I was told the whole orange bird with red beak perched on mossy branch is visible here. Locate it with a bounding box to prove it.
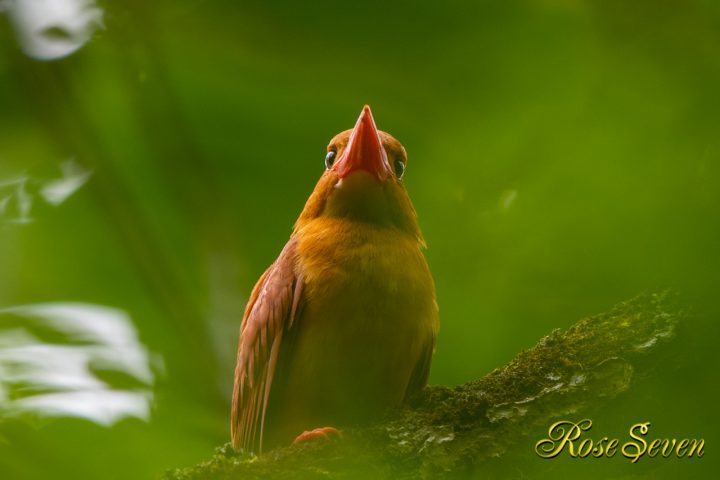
[231,105,438,452]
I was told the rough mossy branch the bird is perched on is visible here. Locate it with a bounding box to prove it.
[164,292,684,480]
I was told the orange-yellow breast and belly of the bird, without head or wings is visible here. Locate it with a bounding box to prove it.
[268,217,438,448]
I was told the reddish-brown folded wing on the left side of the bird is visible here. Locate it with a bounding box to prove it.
[230,238,302,451]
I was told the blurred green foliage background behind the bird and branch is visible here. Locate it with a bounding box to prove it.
[0,0,720,479]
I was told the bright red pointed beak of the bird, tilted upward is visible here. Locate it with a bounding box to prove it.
[333,105,391,183]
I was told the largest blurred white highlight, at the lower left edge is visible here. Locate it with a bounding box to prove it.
[0,303,155,426]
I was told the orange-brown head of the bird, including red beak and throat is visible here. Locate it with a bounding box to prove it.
[295,105,423,243]
